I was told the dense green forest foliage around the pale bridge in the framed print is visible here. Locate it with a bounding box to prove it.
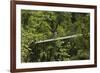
[21,10,90,62]
